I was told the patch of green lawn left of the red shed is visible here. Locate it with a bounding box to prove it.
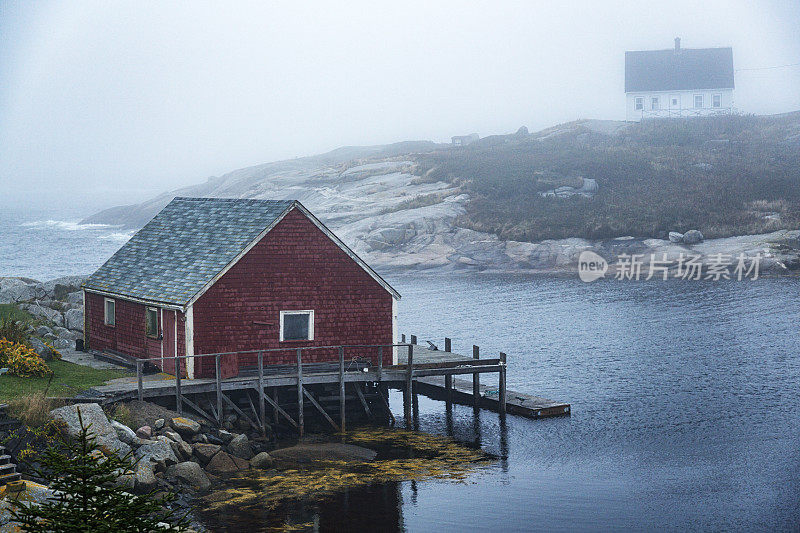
[0,361,130,401]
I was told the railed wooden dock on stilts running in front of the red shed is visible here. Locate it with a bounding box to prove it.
[94,335,570,435]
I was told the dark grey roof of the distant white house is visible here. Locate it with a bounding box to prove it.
[625,48,734,93]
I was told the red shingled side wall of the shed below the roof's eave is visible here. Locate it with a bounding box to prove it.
[85,292,186,372]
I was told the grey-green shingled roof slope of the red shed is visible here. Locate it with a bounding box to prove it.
[84,198,294,306]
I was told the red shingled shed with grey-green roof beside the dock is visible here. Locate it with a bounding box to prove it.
[83,198,400,378]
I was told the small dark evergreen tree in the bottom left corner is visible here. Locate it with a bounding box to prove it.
[11,410,188,533]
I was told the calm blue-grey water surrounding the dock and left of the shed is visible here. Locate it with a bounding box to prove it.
[0,210,800,532]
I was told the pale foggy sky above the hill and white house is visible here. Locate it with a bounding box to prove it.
[0,0,800,210]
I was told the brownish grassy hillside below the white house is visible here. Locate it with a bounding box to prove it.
[416,113,800,241]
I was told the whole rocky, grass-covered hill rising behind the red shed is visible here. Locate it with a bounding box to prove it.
[84,112,800,271]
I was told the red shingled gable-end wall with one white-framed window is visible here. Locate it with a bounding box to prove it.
[194,209,393,377]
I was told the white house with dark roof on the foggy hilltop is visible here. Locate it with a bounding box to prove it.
[625,38,734,121]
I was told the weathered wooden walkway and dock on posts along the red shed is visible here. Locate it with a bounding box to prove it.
[87,336,570,435]
